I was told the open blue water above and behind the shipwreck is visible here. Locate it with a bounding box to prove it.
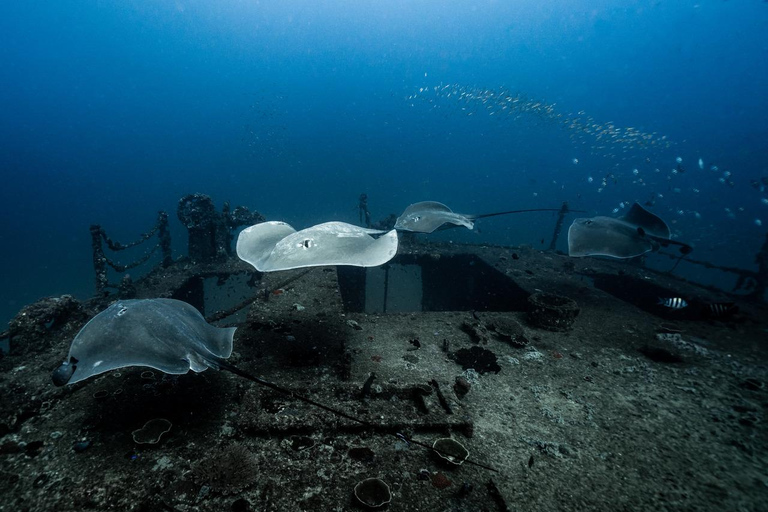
[0,0,768,321]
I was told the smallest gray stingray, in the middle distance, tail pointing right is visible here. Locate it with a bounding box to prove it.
[395,201,573,233]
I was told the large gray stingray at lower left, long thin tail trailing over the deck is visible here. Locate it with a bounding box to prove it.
[52,299,496,471]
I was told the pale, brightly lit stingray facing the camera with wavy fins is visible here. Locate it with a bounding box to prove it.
[237,221,397,272]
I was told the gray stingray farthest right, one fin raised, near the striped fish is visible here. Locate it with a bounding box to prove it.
[568,203,693,258]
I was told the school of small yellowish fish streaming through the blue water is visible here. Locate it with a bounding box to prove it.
[406,84,768,234]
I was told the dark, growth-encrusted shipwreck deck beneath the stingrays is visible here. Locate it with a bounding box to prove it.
[0,244,768,512]
